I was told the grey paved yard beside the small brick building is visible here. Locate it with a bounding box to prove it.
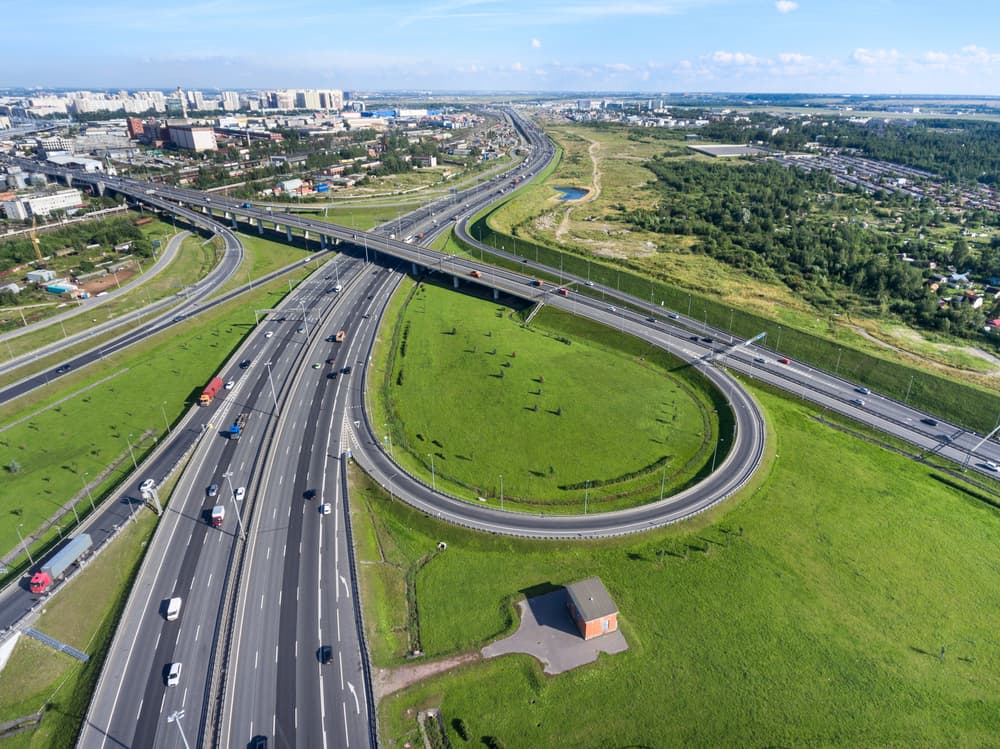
[483,588,628,674]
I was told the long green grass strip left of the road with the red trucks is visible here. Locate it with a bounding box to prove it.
[0,262,308,572]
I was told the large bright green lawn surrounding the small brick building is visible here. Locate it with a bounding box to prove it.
[364,392,1000,749]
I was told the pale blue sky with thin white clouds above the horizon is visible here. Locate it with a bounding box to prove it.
[7,0,1000,95]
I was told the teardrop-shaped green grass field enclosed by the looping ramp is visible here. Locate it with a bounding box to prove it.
[371,283,718,512]
